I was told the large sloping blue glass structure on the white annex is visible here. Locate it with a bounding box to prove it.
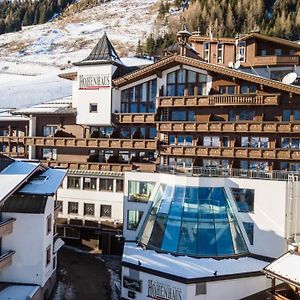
[138,184,248,257]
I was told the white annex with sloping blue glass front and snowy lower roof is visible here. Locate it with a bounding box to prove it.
[122,169,300,300]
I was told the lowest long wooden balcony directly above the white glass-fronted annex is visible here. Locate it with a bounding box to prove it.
[160,145,300,160]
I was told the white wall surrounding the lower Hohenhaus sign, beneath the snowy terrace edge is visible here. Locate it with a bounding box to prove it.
[122,266,271,300]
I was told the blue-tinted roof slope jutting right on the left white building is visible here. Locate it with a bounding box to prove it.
[19,169,67,195]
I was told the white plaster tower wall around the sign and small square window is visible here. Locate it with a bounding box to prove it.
[73,64,115,126]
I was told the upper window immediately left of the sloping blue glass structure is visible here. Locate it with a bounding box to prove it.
[128,181,155,202]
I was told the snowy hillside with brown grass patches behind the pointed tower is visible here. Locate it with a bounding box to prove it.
[0,0,159,107]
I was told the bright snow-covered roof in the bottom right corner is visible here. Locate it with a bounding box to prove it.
[264,251,300,288]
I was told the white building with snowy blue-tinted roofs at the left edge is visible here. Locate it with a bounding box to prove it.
[0,156,66,299]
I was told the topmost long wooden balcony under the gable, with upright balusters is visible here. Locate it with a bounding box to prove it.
[157,94,280,107]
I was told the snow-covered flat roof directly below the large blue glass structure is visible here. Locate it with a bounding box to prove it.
[122,243,268,279]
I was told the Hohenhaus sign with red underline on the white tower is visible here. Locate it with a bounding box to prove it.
[79,74,111,90]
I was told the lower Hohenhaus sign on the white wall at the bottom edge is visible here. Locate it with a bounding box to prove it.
[148,280,182,300]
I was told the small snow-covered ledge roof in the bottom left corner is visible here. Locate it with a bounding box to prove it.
[0,285,40,300]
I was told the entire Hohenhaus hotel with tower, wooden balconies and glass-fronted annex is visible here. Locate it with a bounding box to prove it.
[0,30,300,300]
